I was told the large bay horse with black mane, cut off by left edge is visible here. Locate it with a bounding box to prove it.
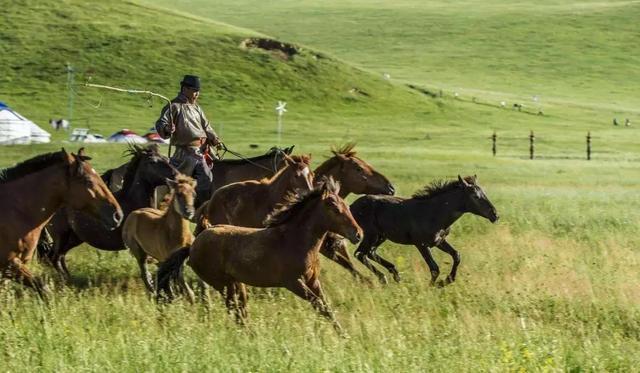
[0,149,123,296]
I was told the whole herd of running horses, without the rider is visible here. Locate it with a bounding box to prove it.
[0,144,498,328]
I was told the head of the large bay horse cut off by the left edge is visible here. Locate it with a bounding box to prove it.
[62,148,124,229]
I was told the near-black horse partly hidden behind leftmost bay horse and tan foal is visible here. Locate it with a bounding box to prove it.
[40,144,178,278]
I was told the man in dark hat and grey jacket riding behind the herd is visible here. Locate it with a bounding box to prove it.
[155,75,222,206]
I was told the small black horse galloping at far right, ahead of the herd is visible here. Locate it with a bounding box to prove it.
[351,176,498,285]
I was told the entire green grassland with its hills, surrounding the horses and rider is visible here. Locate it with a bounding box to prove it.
[0,0,640,372]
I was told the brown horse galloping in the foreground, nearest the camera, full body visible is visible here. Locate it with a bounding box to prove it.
[158,180,362,329]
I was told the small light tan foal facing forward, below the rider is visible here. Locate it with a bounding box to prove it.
[122,175,196,292]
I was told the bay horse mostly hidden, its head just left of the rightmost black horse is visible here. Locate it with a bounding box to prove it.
[314,143,395,281]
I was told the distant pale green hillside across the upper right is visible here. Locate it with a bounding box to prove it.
[154,0,640,109]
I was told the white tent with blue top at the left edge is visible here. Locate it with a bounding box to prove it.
[0,102,51,145]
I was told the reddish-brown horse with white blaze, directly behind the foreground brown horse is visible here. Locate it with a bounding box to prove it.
[195,155,313,231]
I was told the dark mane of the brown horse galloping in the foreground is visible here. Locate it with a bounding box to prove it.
[263,178,340,228]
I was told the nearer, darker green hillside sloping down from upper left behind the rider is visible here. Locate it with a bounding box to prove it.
[0,0,435,141]
